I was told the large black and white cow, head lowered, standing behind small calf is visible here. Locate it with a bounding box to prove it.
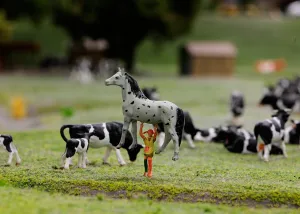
[60,122,144,166]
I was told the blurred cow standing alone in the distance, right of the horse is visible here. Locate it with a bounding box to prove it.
[230,91,245,125]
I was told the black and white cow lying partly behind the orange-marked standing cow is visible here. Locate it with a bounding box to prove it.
[219,126,282,154]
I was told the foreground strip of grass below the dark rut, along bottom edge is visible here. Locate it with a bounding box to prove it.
[0,187,298,214]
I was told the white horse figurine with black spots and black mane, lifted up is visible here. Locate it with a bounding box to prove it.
[105,68,184,161]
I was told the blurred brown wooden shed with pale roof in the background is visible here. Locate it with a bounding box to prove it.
[181,41,237,77]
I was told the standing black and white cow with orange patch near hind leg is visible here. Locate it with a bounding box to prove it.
[254,109,290,161]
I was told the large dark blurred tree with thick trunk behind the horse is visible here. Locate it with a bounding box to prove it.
[0,0,202,71]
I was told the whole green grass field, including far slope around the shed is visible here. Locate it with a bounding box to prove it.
[0,15,300,213]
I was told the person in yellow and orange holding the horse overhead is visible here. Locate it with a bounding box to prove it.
[140,123,157,178]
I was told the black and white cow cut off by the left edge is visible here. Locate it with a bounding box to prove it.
[0,134,21,166]
